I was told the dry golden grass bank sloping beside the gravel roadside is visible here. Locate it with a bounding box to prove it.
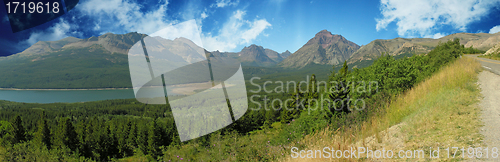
[283,57,481,161]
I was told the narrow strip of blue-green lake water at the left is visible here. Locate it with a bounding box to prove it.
[0,89,135,103]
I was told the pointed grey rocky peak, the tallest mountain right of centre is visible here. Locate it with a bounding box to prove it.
[279,30,360,68]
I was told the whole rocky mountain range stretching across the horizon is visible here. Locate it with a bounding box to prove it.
[0,30,500,88]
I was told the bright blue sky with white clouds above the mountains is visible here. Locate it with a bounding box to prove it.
[0,0,500,56]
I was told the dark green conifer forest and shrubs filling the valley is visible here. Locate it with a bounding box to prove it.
[0,39,484,161]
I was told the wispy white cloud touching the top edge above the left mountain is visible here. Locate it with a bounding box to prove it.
[78,0,170,34]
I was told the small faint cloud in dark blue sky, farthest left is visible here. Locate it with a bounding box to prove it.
[19,19,80,47]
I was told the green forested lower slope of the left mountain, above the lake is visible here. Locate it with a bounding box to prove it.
[0,45,132,89]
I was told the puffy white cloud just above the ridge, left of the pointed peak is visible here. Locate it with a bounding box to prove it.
[201,10,271,51]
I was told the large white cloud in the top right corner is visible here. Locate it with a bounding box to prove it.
[376,0,499,37]
